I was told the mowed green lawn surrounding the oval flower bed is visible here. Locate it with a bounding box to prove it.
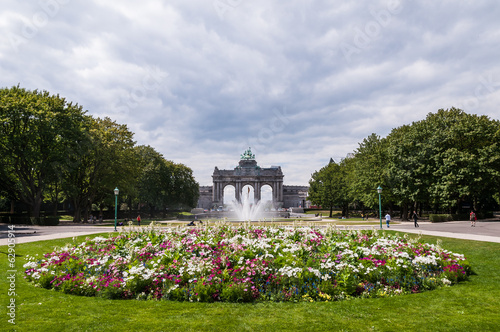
[0,234,500,331]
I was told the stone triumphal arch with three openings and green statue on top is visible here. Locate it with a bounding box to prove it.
[212,148,283,207]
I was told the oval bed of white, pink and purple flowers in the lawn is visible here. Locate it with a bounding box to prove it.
[24,225,471,302]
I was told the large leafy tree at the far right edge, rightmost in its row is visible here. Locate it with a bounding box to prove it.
[424,108,499,212]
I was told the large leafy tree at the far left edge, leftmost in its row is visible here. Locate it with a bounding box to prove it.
[0,86,85,217]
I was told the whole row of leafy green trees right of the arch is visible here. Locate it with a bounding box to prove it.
[310,108,500,218]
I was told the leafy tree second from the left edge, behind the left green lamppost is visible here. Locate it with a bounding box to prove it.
[63,118,138,222]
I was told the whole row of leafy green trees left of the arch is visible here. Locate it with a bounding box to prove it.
[0,86,198,221]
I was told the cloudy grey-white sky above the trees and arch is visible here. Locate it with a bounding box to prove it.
[0,0,500,185]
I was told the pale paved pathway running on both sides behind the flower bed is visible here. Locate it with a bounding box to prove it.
[0,220,500,245]
